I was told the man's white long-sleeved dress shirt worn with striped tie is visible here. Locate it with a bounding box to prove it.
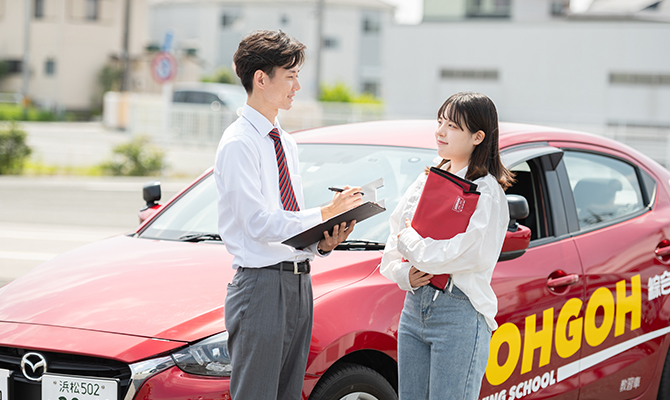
[214,104,321,269]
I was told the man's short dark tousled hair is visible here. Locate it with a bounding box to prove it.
[233,31,305,93]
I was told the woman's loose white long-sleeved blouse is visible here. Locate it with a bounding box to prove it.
[381,167,509,331]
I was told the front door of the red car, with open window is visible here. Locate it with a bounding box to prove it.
[479,143,583,400]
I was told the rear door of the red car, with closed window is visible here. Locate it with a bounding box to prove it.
[563,144,670,400]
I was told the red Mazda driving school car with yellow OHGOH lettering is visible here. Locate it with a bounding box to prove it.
[0,121,670,400]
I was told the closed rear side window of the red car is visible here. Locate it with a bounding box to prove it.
[563,151,645,229]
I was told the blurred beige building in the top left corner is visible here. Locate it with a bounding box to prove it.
[0,0,147,110]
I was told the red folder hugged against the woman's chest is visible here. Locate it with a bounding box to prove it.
[412,167,480,291]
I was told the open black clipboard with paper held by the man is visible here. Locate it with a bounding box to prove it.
[282,178,386,249]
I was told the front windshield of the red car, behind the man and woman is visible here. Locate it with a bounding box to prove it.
[140,144,437,243]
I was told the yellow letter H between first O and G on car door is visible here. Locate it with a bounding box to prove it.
[521,308,554,374]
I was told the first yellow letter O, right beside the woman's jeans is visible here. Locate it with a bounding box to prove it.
[486,322,521,386]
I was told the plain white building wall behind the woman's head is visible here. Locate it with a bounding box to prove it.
[383,20,670,125]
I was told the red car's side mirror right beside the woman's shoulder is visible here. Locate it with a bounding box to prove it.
[498,194,530,261]
